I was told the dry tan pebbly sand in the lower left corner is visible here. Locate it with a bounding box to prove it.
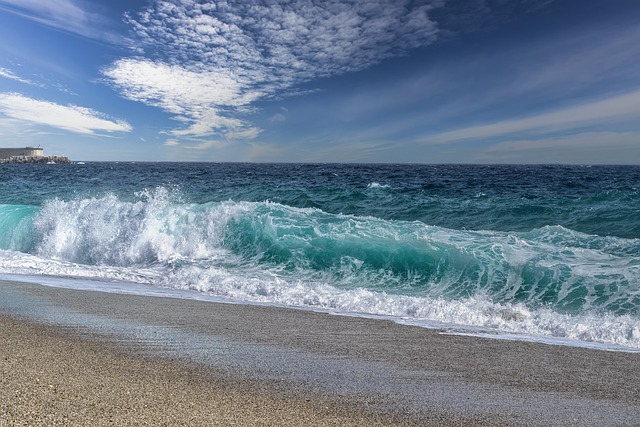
[0,316,418,427]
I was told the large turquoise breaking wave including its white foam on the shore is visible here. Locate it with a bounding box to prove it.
[0,188,640,348]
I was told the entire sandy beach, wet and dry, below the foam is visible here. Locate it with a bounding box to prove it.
[0,281,640,427]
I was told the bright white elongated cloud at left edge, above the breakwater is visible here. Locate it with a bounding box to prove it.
[0,93,132,135]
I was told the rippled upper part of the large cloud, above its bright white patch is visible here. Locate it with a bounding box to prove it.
[130,0,439,85]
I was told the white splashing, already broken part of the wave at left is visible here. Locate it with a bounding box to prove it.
[34,188,241,266]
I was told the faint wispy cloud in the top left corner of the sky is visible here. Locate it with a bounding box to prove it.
[0,0,125,44]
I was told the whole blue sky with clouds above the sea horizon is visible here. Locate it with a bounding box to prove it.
[0,0,640,164]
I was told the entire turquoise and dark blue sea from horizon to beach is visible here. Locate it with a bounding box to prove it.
[0,162,640,351]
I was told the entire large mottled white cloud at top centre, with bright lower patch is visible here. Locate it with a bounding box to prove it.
[103,0,442,143]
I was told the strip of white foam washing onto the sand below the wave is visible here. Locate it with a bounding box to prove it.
[0,251,640,351]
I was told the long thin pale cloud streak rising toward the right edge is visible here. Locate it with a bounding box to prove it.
[423,91,640,144]
